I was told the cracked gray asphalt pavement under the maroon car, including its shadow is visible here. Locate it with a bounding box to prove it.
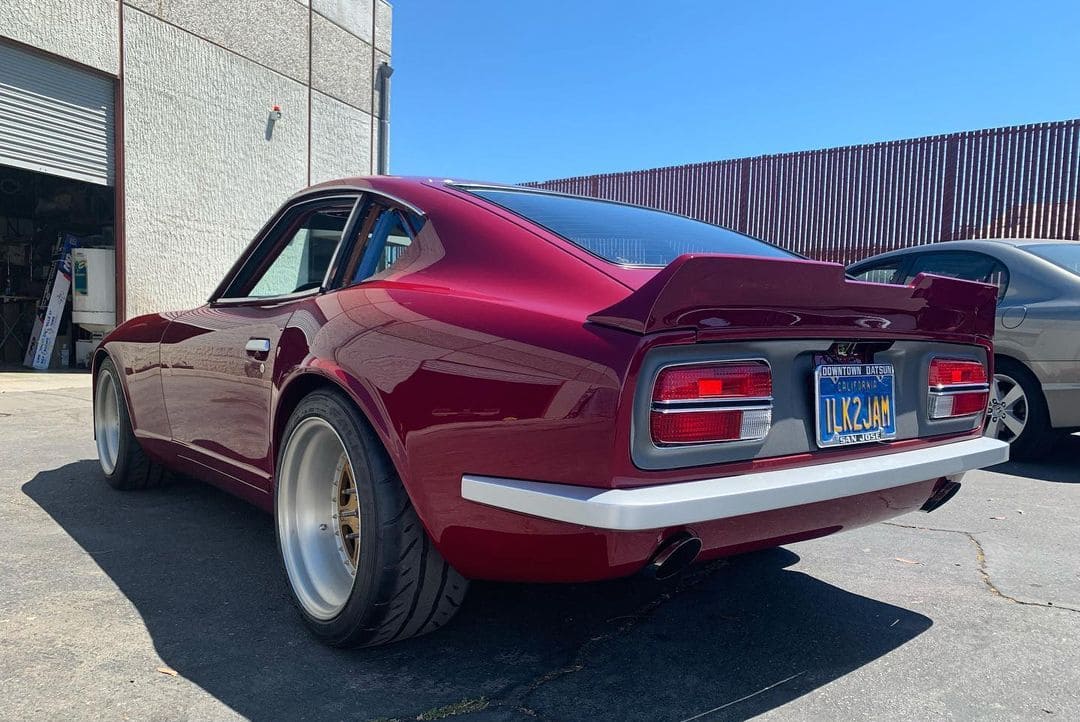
[0,373,1080,722]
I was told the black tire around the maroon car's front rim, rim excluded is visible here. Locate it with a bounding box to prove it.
[94,358,164,491]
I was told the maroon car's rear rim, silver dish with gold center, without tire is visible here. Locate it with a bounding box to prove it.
[278,417,361,619]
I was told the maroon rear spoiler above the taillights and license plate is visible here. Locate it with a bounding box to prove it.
[589,255,997,340]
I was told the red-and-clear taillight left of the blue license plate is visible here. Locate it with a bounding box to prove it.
[649,360,772,446]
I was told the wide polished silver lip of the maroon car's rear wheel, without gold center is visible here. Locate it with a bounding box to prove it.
[274,416,363,622]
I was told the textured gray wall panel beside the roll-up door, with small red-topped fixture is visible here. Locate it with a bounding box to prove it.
[124,8,308,317]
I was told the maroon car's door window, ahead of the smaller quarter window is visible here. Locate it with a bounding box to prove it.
[225,199,355,299]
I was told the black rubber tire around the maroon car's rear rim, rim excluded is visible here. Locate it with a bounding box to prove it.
[274,390,469,646]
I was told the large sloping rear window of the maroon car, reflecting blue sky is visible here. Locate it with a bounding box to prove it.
[465,188,799,265]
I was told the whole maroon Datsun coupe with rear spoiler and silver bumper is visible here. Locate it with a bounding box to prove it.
[93,177,1008,645]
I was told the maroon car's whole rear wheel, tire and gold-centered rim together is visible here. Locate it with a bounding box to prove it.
[274,391,469,646]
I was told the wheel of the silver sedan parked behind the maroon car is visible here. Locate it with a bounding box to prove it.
[986,359,1054,459]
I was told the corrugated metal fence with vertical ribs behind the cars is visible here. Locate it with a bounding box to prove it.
[524,119,1080,263]
